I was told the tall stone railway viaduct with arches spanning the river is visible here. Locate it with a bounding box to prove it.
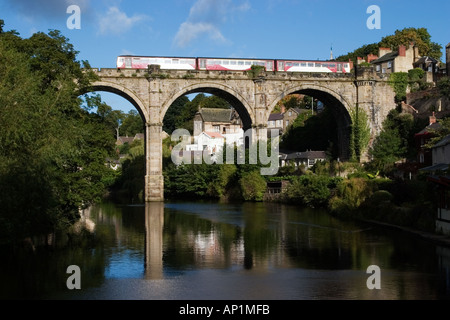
[91,66,396,202]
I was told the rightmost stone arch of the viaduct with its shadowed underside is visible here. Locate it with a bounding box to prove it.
[266,84,354,160]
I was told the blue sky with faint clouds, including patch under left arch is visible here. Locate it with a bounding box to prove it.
[0,0,450,112]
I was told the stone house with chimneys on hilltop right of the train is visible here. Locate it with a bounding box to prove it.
[371,44,420,74]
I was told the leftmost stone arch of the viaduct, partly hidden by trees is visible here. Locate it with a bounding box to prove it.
[86,81,149,123]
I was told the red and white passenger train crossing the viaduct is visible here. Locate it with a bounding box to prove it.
[117,56,352,73]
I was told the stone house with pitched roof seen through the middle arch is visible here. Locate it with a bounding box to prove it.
[194,108,242,137]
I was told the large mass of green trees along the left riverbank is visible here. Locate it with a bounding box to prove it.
[0,23,115,241]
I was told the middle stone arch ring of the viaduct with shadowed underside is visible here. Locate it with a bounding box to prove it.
[161,82,255,130]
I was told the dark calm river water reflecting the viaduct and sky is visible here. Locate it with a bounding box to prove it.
[0,202,450,300]
